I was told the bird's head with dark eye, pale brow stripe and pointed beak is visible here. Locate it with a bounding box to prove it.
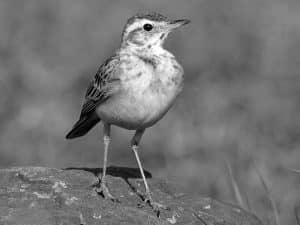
[122,13,190,49]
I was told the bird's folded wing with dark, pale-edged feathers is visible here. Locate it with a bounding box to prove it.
[80,56,120,118]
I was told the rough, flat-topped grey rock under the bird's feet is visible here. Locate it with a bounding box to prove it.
[0,167,262,225]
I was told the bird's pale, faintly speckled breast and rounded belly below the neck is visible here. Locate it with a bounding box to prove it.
[98,53,183,129]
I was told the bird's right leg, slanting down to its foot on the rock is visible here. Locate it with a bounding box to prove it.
[131,129,167,213]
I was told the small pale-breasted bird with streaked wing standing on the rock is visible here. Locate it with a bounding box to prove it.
[66,12,190,210]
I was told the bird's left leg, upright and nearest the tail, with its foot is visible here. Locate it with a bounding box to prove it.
[96,123,117,201]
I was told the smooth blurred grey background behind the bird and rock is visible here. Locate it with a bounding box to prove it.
[0,0,300,224]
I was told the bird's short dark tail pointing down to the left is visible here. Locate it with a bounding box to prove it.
[66,113,100,139]
